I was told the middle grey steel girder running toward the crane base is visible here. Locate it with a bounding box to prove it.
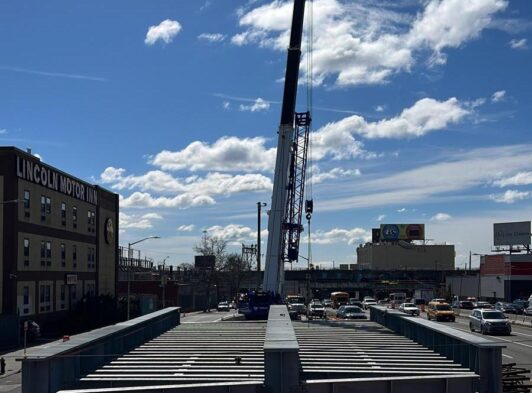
[264,305,300,393]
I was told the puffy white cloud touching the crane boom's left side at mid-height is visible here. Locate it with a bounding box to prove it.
[152,137,276,172]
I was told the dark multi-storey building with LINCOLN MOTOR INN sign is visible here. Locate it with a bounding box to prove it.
[0,147,118,322]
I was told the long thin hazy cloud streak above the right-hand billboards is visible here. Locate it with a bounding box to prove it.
[320,145,532,211]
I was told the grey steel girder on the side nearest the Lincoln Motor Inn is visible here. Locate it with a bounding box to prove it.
[18,307,180,393]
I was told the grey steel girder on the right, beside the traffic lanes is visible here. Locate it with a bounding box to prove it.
[370,306,506,393]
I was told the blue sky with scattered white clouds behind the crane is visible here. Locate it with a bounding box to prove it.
[0,0,532,266]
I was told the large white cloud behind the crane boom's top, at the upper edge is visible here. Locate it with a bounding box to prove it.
[231,0,508,86]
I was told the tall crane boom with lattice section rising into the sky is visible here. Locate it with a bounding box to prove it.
[262,0,310,294]
